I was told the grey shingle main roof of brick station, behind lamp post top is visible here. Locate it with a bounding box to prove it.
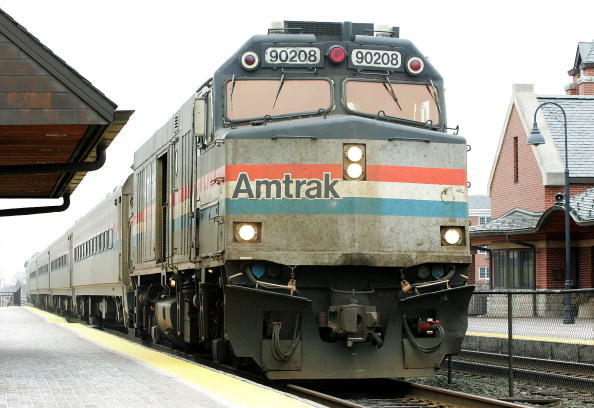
[537,96,594,177]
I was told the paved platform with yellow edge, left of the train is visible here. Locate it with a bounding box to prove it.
[0,306,319,408]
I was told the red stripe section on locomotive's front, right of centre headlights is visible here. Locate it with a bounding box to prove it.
[367,165,466,186]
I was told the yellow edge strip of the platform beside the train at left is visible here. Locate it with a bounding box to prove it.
[24,306,312,408]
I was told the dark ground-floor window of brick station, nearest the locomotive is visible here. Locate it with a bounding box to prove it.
[493,248,535,289]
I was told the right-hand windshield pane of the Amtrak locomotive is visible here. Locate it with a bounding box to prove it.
[344,80,439,125]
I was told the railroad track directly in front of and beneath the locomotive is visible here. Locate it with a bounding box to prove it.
[286,379,527,408]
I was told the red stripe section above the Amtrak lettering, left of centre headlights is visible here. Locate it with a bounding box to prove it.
[225,164,342,181]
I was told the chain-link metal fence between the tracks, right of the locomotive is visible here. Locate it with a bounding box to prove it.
[444,289,594,397]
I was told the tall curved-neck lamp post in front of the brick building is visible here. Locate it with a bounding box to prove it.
[527,102,575,324]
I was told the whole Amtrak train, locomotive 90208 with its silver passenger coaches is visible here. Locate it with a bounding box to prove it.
[27,21,474,380]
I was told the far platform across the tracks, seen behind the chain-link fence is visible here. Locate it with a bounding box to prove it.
[462,316,594,364]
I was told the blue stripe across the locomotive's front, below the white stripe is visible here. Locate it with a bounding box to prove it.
[226,197,468,218]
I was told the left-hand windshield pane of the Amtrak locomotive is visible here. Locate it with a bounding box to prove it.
[227,76,332,120]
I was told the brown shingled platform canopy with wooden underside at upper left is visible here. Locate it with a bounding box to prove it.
[0,10,132,198]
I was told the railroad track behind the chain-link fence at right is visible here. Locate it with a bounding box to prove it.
[452,350,594,392]
